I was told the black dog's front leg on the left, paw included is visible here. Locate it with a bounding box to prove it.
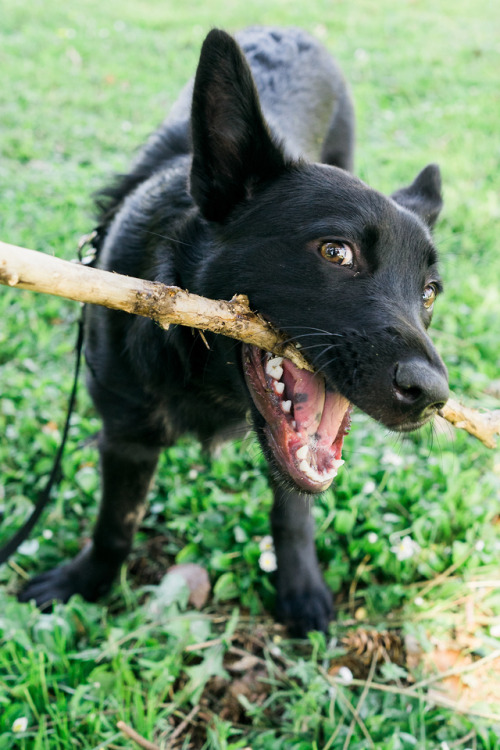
[19,434,159,607]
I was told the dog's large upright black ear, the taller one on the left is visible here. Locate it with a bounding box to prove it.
[190,29,286,221]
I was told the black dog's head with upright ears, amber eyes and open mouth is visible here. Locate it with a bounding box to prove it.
[190,31,448,493]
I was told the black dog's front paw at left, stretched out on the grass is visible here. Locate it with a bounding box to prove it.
[18,547,117,610]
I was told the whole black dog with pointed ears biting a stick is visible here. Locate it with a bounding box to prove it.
[21,29,448,634]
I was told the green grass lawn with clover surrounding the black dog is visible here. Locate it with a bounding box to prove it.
[0,0,500,750]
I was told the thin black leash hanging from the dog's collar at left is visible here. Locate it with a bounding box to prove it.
[0,230,98,565]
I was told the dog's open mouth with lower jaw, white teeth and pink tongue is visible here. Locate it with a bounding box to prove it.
[243,344,352,493]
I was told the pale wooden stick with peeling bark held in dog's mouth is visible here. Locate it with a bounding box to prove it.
[0,241,500,448]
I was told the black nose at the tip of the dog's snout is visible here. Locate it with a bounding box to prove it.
[394,358,449,411]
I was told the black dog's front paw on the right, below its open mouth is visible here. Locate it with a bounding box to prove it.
[276,581,333,638]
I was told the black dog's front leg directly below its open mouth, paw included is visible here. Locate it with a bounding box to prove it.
[271,486,333,637]
